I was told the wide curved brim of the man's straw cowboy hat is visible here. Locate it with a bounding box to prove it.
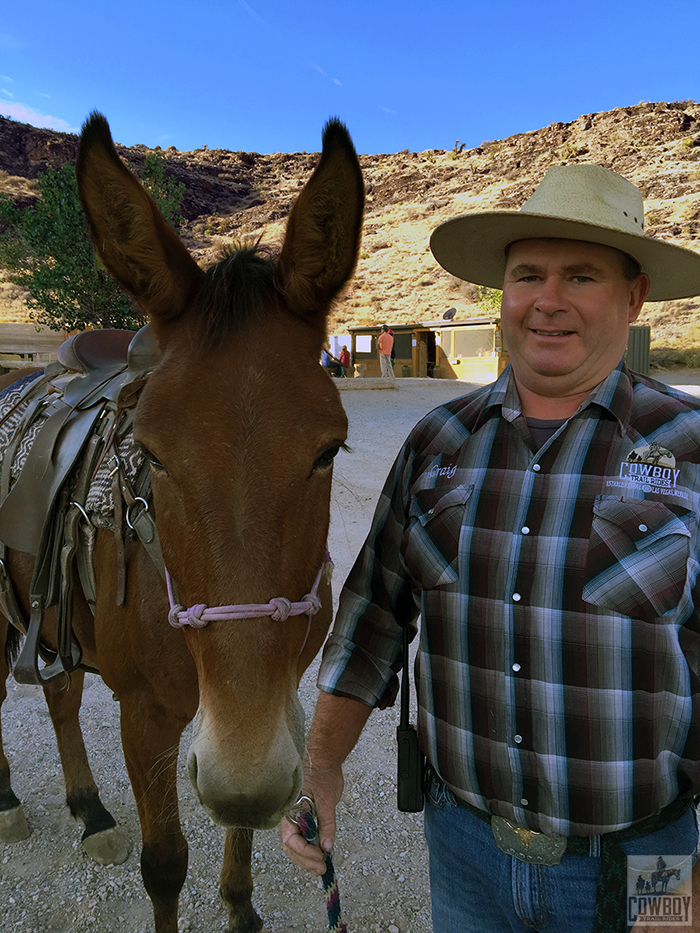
[430,211,700,301]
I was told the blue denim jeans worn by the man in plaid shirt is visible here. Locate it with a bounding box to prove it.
[425,785,698,933]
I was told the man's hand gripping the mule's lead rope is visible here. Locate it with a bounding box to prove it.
[280,761,343,877]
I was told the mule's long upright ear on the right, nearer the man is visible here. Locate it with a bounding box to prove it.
[277,120,365,325]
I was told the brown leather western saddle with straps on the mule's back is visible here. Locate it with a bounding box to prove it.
[0,325,164,684]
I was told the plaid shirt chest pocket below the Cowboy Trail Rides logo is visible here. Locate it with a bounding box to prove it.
[583,496,696,621]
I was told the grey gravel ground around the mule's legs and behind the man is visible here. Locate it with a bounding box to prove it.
[0,379,476,933]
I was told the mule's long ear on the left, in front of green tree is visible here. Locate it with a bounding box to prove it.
[76,112,203,330]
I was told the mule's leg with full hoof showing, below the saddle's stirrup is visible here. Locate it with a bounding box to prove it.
[44,671,130,865]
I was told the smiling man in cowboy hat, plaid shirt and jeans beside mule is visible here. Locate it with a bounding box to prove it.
[282,165,700,933]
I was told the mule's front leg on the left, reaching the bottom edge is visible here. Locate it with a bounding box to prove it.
[121,692,187,933]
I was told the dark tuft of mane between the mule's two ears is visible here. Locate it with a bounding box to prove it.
[196,243,277,352]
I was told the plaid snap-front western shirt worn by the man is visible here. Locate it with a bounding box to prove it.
[319,364,700,836]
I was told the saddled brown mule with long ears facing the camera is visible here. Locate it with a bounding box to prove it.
[0,114,364,933]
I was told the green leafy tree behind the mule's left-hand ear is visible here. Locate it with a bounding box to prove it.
[0,153,184,330]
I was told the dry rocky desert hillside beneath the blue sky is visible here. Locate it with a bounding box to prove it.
[0,101,700,348]
